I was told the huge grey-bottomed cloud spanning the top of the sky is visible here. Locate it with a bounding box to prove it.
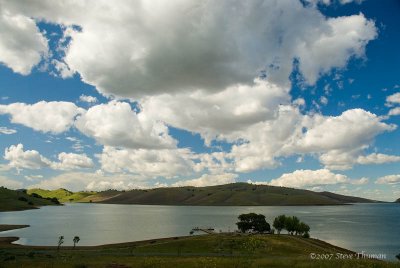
[2,0,377,98]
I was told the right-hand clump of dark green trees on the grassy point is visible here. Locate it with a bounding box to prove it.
[272,215,310,237]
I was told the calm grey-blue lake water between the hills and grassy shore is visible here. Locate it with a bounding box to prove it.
[0,204,400,259]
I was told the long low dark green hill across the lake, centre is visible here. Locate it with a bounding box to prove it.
[93,183,376,206]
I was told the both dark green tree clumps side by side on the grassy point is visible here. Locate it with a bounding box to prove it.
[236,213,310,237]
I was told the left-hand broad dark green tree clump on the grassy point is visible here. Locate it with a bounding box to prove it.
[236,213,271,233]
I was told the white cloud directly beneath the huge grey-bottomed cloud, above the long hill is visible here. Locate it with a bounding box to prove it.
[141,79,290,144]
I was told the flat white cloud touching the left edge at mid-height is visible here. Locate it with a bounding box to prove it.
[0,101,84,134]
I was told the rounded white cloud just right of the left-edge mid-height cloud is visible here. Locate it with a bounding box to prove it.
[75,101,176,149]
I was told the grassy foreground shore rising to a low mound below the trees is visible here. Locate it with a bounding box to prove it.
[0,234,399,268]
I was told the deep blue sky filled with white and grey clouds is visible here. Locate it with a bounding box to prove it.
[0,0,400,201]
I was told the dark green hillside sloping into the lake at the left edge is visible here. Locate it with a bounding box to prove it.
[0,187,58,211]
